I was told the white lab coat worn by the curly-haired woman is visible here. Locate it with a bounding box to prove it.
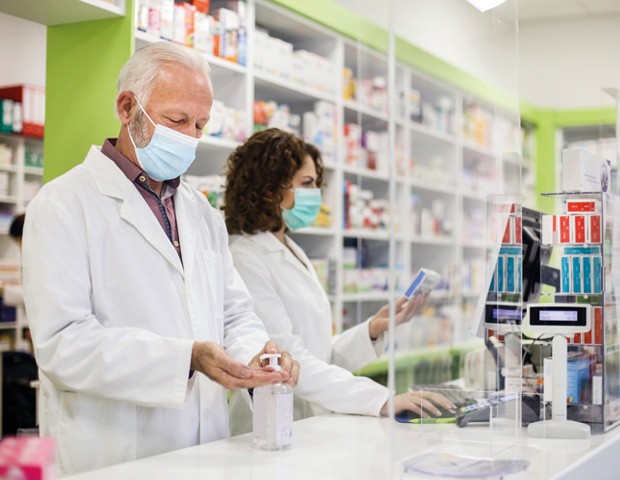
[230,232,388,434]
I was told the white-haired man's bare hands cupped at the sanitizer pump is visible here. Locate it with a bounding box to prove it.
[190,341,299,390]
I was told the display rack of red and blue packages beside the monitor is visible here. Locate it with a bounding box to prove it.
[541,192,620,431]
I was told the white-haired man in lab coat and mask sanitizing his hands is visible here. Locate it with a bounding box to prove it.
[23,42,299,473]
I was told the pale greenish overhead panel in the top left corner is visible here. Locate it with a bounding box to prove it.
[0,0,125,25]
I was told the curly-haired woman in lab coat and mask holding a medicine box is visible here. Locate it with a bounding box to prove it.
[224,128,454,433]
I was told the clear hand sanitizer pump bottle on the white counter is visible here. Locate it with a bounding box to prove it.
[252,353,293,450]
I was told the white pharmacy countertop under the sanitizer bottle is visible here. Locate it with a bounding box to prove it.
[65,414,620,480]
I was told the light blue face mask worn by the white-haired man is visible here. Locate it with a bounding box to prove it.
[128,98,199,182]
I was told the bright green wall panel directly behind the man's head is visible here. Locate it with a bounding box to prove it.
[43,0,134,181]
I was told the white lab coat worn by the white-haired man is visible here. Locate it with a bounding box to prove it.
[23,147,267,473]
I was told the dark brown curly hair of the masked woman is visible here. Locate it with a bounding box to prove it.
[223,128,323,234]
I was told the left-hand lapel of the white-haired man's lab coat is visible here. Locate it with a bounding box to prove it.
[84,147,183,275]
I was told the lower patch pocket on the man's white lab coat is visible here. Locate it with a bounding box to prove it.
[57,391,137,473]
